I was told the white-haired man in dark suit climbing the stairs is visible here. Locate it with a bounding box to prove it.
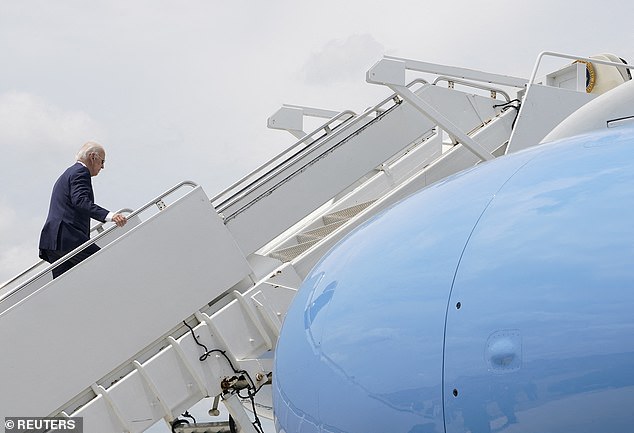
[39,141,127,278]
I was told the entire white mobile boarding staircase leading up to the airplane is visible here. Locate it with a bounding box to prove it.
[0,51,628,433]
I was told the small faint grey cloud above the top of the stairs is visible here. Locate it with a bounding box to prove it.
[302,34,385,85]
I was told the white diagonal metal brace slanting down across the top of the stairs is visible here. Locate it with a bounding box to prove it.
[366,58,494,161]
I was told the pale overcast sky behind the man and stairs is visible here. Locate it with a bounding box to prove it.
[0,0,634,426]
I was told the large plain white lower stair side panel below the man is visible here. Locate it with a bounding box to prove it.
[0,187,249,418]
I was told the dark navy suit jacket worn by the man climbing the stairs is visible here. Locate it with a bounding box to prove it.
[39,162,108,259]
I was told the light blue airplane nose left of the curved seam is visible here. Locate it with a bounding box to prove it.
[274,148,532,433]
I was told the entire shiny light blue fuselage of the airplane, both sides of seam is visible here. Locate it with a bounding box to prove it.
[273,128,634,433]
